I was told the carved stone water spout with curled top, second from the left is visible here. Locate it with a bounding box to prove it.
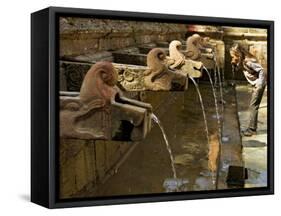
[143,48,186,91]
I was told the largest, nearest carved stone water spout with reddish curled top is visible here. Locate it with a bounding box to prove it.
[60,62,152,141]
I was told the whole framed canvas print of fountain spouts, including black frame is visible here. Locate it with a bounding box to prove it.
[31,7,274,208]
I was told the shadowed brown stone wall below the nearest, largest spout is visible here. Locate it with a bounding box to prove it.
[60,139,133,199]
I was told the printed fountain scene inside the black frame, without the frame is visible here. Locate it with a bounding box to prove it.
[57,17,268,199]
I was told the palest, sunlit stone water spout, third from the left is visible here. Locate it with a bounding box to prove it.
[165,40,203,78]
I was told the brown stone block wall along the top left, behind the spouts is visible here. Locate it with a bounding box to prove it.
[60,17,186,57]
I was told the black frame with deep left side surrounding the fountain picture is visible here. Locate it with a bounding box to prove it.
[31,7,274,208]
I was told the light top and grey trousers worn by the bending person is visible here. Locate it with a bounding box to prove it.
[243,58,266,131]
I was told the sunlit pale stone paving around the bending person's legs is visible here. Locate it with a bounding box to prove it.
[236,84,267,188]
